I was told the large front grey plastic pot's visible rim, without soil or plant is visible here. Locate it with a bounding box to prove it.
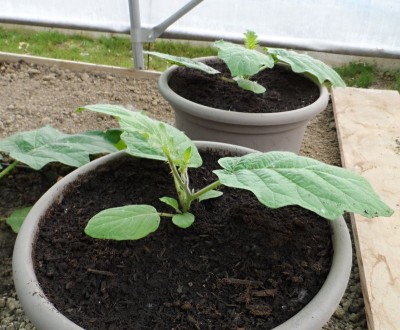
[13,142,352,330]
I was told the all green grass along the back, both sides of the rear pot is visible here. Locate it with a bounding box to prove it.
[0,27,400,91]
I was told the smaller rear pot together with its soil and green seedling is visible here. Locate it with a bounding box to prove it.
[147,31,345,153]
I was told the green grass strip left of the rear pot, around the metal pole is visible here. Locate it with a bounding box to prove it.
[0,27,216,70]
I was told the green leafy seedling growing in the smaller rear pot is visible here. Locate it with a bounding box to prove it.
[145,31,345,94]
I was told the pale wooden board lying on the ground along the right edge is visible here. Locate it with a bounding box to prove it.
[332,88,400,330]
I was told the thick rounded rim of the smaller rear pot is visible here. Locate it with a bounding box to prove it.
[158,56,329,126]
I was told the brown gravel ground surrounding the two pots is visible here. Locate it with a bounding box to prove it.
[0,60,367,330]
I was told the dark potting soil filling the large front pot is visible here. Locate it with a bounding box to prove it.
[34,153,332,330]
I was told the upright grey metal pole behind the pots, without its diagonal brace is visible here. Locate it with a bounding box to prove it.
[128,0,144,70]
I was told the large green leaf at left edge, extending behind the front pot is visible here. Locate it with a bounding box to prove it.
[0,126,117,170]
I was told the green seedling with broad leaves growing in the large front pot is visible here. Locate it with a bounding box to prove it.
[78,105,393,240]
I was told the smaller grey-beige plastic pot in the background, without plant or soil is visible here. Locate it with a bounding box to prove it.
[158,57,329,153]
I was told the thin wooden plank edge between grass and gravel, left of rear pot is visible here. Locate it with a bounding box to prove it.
[0,52,160,80]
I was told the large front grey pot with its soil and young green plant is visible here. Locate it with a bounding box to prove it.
[13,105,392,330]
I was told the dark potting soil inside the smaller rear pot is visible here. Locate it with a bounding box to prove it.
[169,61,319,113]
